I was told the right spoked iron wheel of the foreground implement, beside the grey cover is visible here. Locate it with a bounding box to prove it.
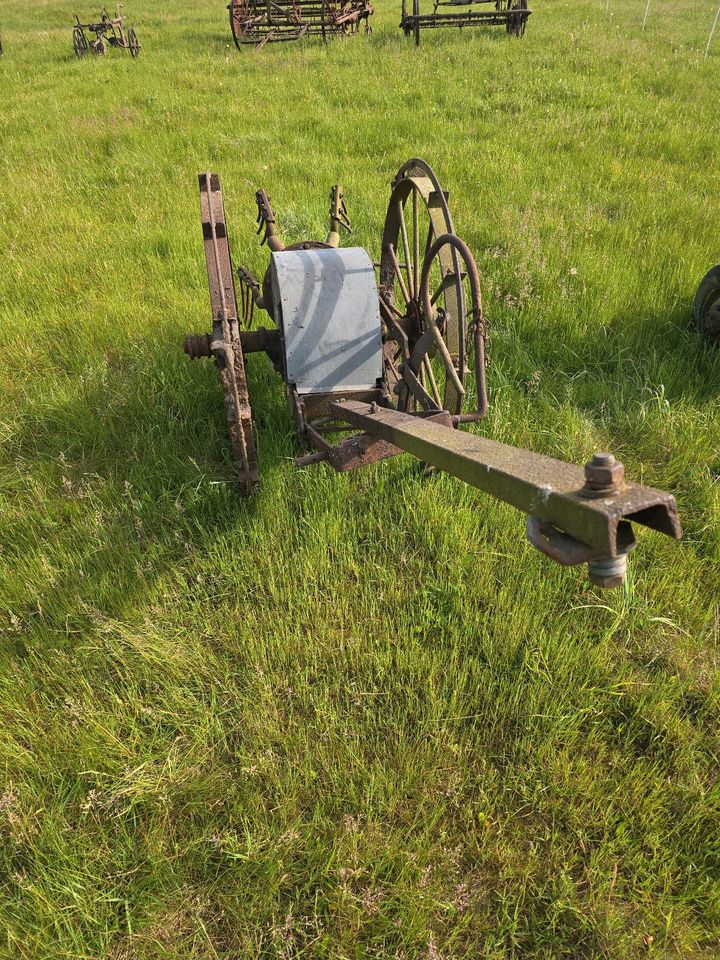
[379,159,487,419]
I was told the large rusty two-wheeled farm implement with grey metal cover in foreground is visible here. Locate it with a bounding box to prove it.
[185,160,680,587]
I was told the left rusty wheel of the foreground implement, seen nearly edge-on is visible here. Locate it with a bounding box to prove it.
[185,173,260,494]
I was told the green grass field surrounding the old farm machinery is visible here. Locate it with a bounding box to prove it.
[0,0,720,960]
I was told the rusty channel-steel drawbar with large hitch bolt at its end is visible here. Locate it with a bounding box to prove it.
[332,401,682,586]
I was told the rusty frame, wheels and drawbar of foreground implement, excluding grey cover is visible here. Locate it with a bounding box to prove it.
[185,160,681,587]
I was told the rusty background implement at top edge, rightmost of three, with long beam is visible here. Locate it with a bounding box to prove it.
[400,0,532,45]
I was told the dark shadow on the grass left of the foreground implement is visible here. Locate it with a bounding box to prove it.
[5,338,297,655]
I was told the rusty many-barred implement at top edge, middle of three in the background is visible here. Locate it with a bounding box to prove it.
[228,0,374,50]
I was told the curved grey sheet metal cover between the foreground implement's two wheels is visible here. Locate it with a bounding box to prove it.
[272,247,382,394]
